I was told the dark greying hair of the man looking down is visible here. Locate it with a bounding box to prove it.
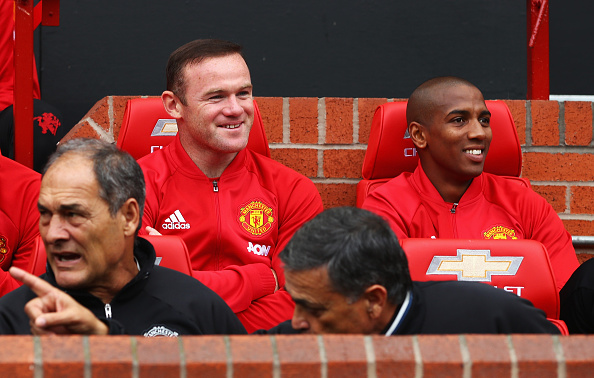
[280,207,412,305]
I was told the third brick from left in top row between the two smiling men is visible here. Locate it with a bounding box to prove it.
[325,97,353,144]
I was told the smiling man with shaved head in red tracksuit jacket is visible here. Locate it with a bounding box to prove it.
[363,77,579,290]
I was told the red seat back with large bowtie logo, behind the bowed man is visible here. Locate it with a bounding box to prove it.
[401,238,559,319]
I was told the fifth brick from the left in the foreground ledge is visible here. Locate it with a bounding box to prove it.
[182,336,227,378]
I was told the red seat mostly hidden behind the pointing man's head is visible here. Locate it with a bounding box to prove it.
[27,235,192,276]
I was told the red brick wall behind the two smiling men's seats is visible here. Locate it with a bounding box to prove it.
[65,96,594,244]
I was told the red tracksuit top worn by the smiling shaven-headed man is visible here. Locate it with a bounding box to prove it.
[363,162,579,290]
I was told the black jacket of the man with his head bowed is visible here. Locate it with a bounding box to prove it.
[256,281,560,335]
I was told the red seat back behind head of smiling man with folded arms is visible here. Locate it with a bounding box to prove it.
[117,97,270,160]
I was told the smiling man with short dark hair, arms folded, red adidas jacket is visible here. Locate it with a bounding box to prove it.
[139,40,322,332]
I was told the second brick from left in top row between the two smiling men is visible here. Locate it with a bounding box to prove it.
[289,97,318,144]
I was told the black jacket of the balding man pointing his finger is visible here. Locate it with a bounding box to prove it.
[0,238,246,336]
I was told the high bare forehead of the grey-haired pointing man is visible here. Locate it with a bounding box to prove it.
[39,154,99,203]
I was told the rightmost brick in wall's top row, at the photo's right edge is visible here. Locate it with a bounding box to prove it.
[565,101,592,146]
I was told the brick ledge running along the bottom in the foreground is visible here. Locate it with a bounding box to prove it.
[0,335,594,378]
